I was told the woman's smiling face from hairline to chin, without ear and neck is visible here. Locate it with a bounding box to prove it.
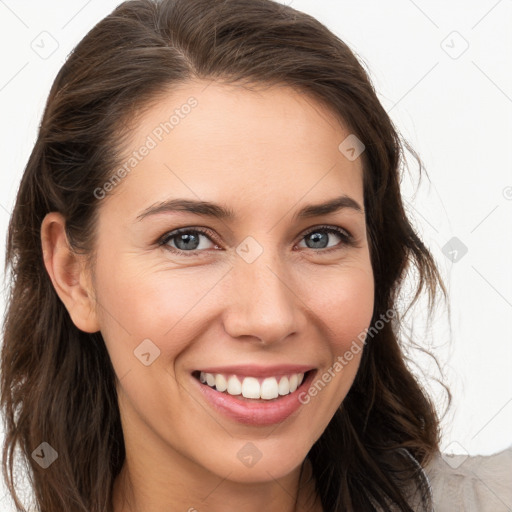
[93,82,374,482]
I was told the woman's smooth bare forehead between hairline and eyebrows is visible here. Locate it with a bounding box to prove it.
[103,81,362,220]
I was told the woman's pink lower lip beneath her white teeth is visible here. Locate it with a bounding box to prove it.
[192,370,316,426]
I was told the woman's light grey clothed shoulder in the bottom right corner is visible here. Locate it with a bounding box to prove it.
[424,446,512,512]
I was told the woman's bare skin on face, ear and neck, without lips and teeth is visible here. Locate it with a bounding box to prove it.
[41,81,374,512]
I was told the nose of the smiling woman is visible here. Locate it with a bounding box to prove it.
[224,241,307,345]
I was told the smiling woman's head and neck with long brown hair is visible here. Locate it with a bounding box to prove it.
[2,0,458,512]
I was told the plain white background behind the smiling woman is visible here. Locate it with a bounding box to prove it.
[0,0,512,508]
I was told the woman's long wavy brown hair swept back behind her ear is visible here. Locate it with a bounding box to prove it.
[1,0,451,512]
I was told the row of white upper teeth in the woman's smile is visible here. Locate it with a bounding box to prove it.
[199,372,304,400]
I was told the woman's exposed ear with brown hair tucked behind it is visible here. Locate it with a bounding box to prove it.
[41,212,100,333]
